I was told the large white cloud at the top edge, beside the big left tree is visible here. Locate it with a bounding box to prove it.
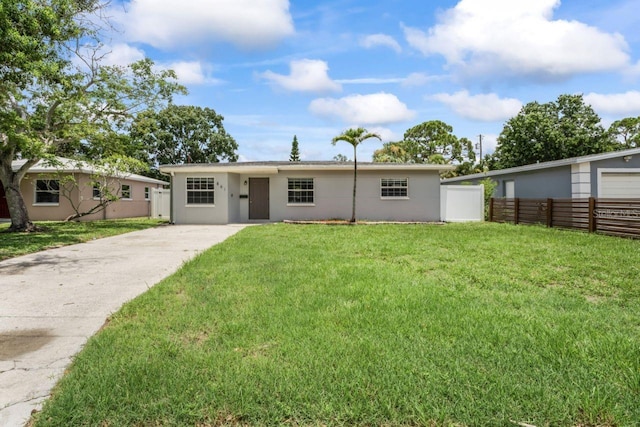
[112,0,295,49]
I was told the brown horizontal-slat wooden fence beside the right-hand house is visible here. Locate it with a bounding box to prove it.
[489,197,640,239]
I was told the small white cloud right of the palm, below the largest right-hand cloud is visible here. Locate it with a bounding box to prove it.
[429,90,522,122]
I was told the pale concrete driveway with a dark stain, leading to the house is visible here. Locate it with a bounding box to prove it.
[0,225,244,426]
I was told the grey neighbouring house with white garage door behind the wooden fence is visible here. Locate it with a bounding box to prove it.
[442,148,640,199]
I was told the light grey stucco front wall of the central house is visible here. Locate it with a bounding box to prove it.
[172,170,440,224]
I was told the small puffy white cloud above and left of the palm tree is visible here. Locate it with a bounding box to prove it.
[260,59,342,92]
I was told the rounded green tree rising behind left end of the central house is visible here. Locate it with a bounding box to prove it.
[130,105,238,176]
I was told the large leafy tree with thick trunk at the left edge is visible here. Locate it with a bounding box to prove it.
[0,0,184,231]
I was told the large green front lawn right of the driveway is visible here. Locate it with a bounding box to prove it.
[35,224,640,427]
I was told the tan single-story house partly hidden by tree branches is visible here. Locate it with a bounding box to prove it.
[0,158,167,221]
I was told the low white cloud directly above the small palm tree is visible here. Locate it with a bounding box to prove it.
[309,92,416,125]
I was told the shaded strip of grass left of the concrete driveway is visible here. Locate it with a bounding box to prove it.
[0,218,165,261]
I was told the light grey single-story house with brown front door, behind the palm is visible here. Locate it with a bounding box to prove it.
[160,162,452,224]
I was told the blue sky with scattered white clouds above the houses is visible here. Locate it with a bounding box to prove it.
[106,0,640,161]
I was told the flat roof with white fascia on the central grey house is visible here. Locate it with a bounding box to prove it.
[160,161,455,175]
